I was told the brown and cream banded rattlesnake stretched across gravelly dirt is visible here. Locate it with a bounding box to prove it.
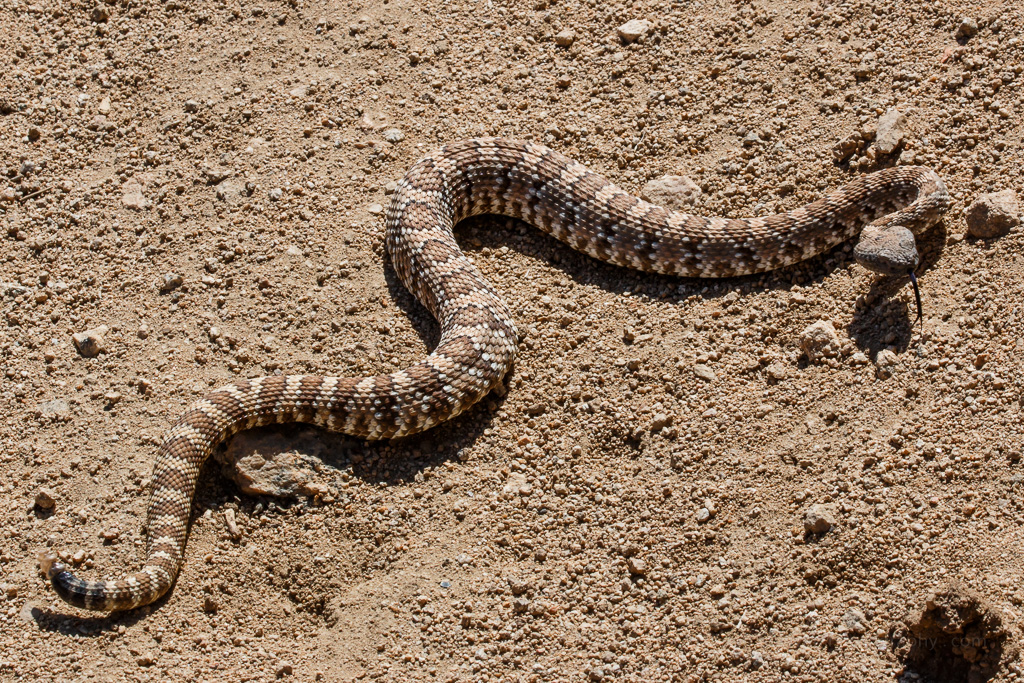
[40,138,949,611]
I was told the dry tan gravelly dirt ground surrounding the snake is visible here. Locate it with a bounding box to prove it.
[0,0,1024,683]
